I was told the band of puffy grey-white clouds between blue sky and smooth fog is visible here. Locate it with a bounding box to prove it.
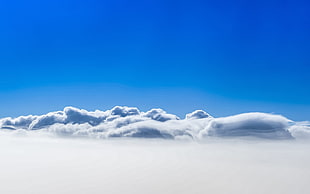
[0,106,310,140]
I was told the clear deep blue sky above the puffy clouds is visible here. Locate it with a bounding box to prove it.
[0,0,310,120]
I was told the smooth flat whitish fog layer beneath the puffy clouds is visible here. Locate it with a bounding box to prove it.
[0,136,310,194]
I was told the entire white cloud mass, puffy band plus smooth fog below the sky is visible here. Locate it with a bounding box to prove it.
[0,106,310,194]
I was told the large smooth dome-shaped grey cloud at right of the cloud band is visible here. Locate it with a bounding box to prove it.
[200,113,292,139]
